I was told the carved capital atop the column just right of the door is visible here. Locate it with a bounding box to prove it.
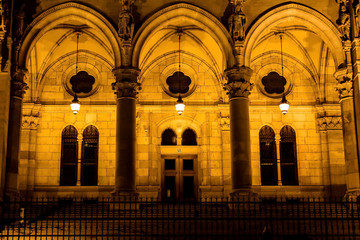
[224,66,254,98]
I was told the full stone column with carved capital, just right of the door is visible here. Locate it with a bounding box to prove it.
[224,66,253,194]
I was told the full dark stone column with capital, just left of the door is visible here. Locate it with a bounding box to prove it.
[112,68,140,195]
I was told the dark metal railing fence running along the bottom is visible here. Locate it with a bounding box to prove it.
[0,197,360,240]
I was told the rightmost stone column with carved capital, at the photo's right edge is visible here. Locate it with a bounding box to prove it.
[335,68,360,197]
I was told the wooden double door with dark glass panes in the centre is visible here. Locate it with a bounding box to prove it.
[161,156,197,201]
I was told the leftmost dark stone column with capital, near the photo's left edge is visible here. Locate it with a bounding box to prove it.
[5,70,28,197]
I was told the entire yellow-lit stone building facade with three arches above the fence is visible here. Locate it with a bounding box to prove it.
[0,0,360,199]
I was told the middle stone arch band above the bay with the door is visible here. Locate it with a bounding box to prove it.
[132,3,235,71]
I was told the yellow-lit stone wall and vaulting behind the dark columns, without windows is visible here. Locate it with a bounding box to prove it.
[7,0,346,197]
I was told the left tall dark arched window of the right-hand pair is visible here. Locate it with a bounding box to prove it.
[259,126,278,185]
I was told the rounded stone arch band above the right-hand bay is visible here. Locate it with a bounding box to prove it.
[244,3,345,66]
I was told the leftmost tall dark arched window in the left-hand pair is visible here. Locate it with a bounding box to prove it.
[60,126,78,186]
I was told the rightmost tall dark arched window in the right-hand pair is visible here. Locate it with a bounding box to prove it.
[280,126,298,185]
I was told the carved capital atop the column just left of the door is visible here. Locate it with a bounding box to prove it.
[111,68,141,98]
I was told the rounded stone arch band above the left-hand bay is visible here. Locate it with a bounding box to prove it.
[18,2,121,69]
